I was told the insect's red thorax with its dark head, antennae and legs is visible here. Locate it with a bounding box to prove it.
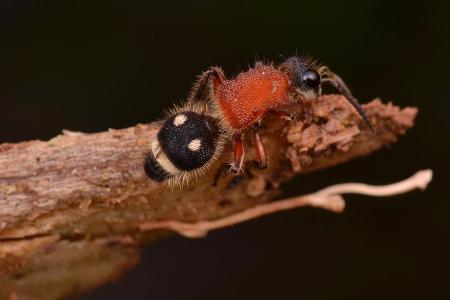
[189,56,372,174]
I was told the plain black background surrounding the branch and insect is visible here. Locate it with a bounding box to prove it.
[0,0,450,300]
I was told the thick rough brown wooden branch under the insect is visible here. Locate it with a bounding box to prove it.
[0,95,417,299]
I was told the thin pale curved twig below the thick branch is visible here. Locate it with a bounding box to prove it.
[139,169,433,238]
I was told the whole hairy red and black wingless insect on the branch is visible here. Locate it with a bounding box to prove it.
[145,56,372,183]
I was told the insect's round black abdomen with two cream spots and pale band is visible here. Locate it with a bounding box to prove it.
[144,102,225,186]
